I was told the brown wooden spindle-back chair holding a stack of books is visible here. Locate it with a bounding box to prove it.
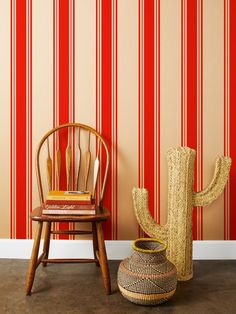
[26,123,111,295]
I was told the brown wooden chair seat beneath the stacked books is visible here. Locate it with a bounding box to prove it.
[30,206,110,222]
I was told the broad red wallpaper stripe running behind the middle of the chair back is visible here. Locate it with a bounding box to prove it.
[59,0,69,239]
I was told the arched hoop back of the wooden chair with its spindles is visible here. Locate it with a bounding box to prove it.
[35,123,110,205]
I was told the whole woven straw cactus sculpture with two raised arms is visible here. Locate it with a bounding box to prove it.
[133,147,231,280]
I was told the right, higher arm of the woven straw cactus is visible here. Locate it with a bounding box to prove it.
[193,156,231,206]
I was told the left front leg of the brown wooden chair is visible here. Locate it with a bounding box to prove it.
[25,221,43,295]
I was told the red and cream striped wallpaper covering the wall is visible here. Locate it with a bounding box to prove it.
[0,0,236,240]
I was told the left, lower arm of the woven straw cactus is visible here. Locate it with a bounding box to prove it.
[132,188,168,241]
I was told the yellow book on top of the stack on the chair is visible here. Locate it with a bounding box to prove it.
[47,190,92,201]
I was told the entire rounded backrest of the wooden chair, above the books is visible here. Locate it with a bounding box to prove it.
[36,123,110,205]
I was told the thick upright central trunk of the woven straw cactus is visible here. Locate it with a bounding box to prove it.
[167,149,195,280]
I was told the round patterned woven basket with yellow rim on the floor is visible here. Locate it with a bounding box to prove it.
[118,238,177,305]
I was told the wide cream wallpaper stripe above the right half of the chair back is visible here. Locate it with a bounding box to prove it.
[74,0,96,238]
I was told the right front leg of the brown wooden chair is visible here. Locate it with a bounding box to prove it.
[96,222,111,294]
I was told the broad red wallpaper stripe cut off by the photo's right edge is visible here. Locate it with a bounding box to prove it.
[230,0,236,240]
